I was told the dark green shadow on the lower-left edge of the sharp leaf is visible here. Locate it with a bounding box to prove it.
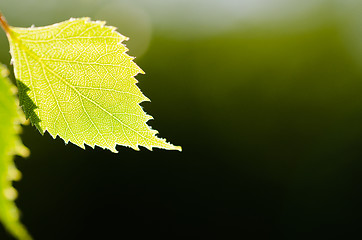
[16,80,44,134]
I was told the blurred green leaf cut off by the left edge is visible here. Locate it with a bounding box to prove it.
[0,65,31,240]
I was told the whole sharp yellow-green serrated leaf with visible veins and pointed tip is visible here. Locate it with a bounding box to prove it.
[8,18,181,152]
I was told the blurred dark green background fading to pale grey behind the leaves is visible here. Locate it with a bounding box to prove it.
[0,0,362,240]
